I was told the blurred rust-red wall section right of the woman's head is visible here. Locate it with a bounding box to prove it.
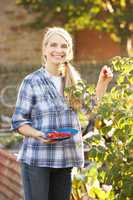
[75,29,121,61]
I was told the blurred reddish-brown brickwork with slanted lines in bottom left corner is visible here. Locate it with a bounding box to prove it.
[0,149,23,200]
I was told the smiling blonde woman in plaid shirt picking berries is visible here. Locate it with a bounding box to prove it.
[12,27,112,200]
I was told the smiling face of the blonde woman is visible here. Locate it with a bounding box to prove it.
[44,34,69,66]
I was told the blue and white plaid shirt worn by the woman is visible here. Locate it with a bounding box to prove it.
[12,67,84,168]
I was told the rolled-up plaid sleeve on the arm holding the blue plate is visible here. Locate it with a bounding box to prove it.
[11,78,33,130]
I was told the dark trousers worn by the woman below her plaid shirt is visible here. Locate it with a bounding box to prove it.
[21,163,72,200]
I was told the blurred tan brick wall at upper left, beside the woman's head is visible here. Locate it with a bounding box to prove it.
[0,0,43,67]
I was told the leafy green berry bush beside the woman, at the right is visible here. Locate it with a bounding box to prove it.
[71,57,133,200]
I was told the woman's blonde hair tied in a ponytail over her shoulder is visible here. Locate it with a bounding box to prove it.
[42,27,81,110]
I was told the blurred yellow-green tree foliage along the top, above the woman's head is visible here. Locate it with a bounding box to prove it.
[16,0,133,53]
